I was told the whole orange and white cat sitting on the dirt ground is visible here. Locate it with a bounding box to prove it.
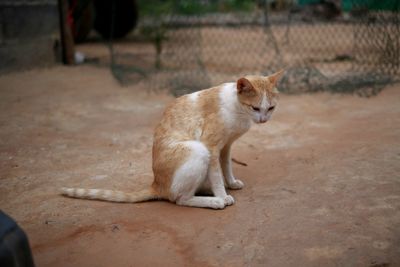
[62,70,284,209]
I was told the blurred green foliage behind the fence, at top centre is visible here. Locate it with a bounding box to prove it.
[137,0,258,16]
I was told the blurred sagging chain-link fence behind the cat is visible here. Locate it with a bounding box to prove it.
[89,0,400,96]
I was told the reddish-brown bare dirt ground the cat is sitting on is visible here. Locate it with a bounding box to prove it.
[0,66,400,267]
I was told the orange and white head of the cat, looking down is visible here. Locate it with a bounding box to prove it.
[236,70,284,123]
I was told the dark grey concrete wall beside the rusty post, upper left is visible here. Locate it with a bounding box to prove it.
[0,0,61,73]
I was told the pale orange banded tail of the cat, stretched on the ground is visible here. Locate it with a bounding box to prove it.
[61,187,160,203]
